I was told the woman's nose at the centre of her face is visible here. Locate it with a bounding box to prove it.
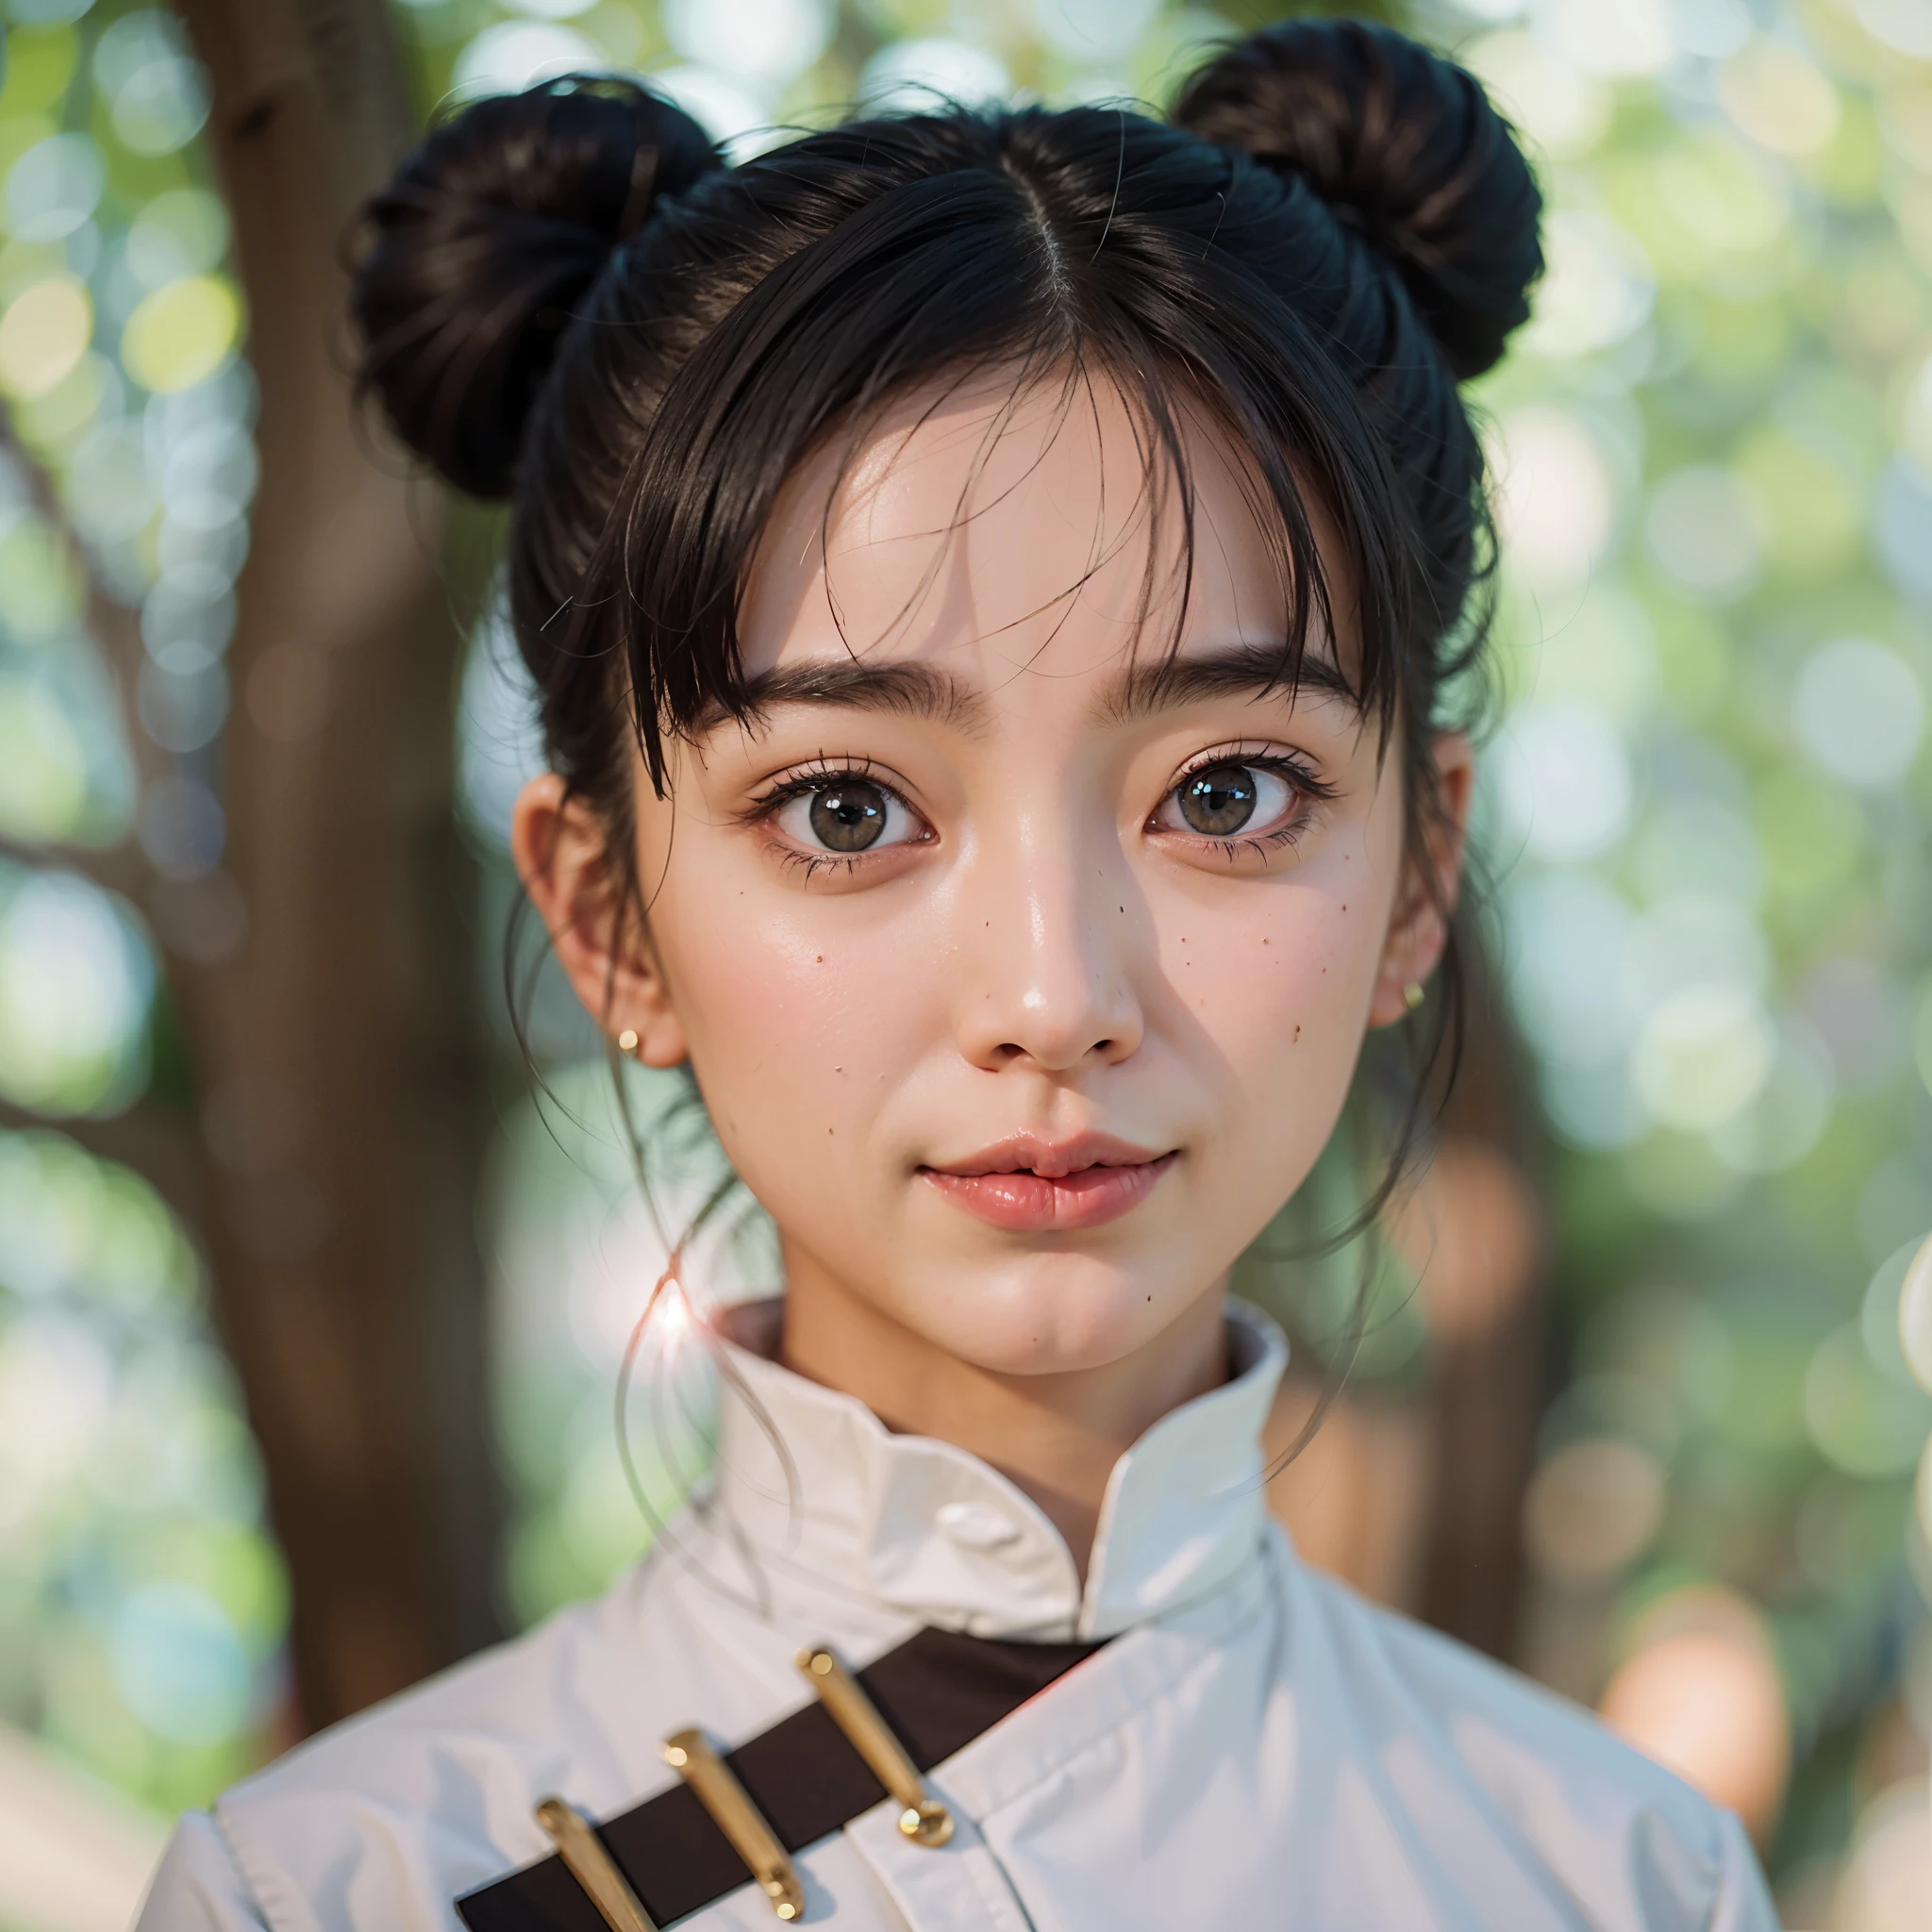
[958,811,1145,1074]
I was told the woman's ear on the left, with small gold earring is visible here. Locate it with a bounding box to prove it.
[510,771,686,1066]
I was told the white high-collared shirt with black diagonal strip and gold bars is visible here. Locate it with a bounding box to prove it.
[137,1306,1775,1932]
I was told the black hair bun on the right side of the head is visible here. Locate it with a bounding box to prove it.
[1173,19,1543,376]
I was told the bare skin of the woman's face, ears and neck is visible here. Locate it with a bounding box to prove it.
[514,378,1474,1569]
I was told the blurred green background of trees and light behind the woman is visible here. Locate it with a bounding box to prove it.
[0,0,1932,1932]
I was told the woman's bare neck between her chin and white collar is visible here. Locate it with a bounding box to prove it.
[778,1248,1226,1578]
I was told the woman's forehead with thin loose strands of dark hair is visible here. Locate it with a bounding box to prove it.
[738,371,1287,686]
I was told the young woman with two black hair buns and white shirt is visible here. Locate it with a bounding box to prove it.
[143,24,1774,1932]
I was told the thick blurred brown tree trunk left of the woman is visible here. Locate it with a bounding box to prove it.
[172,0,496,1725]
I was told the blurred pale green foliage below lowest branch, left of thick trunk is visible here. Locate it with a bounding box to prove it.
[0,1130,288,1812]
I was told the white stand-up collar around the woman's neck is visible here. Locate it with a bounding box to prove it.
[713,1300,1289,1641]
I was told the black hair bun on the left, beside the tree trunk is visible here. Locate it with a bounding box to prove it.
[350,77,721,496]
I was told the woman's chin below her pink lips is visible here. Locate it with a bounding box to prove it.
[892,1248,1209,1375]
